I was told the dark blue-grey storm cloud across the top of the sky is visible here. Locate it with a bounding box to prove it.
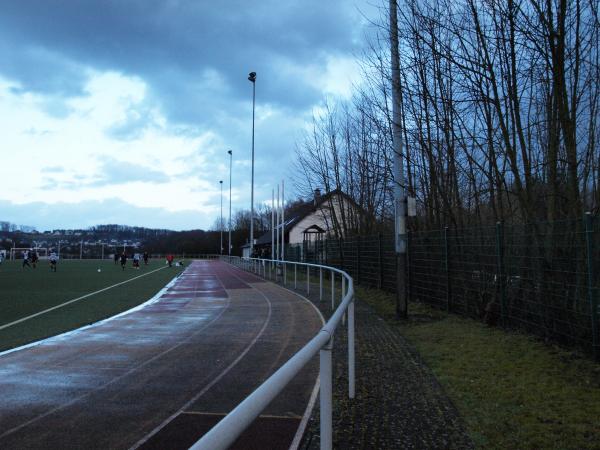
[0,0,356,122]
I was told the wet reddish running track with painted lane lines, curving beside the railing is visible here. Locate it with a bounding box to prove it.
[0,261,321,449]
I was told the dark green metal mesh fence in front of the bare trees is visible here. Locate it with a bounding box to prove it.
[286,215,600,358]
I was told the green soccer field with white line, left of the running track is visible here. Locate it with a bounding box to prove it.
[0,259,183,351]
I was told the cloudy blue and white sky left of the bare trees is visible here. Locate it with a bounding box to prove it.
[0,0,377,231]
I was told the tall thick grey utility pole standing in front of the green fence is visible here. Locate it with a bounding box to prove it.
[390,0,408,318]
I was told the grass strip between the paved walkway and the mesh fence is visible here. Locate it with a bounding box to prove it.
[357,289,600,449]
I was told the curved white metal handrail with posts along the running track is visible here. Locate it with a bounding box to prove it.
[190,256,355,450]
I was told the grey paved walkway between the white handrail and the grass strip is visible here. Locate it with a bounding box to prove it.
[288,286,473,450]
